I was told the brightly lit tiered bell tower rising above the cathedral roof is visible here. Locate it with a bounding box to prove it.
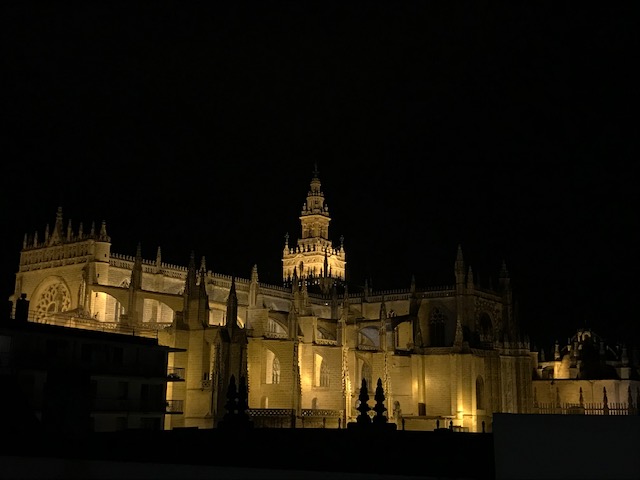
[282,165,347,293]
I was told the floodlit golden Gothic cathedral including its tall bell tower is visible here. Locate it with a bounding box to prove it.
[10,165,537,432]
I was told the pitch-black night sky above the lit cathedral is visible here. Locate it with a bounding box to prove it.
[0,0,640,348]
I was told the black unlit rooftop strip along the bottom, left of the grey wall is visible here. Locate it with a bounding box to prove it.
[0,428,494,480]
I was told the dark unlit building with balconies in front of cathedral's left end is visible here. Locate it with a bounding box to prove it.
[0,298,181,437]
